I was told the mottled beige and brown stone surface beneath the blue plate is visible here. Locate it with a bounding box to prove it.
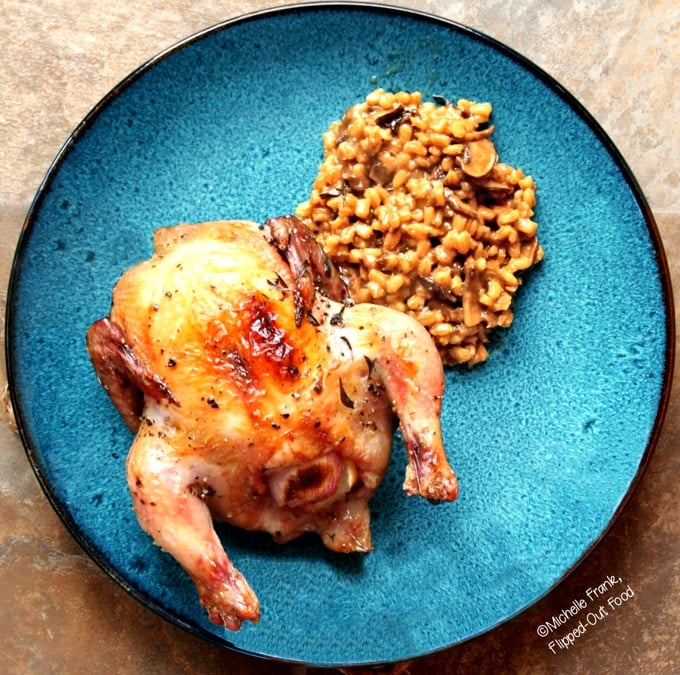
[0,0,680,675]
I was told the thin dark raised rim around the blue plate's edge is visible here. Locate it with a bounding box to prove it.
[4,0,676,667]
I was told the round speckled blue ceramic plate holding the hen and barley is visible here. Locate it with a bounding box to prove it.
[7,3,673,665]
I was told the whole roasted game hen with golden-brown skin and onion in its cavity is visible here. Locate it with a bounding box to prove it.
[87,216,457,630]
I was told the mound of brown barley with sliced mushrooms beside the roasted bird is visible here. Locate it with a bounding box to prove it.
[297,89,543,365]
